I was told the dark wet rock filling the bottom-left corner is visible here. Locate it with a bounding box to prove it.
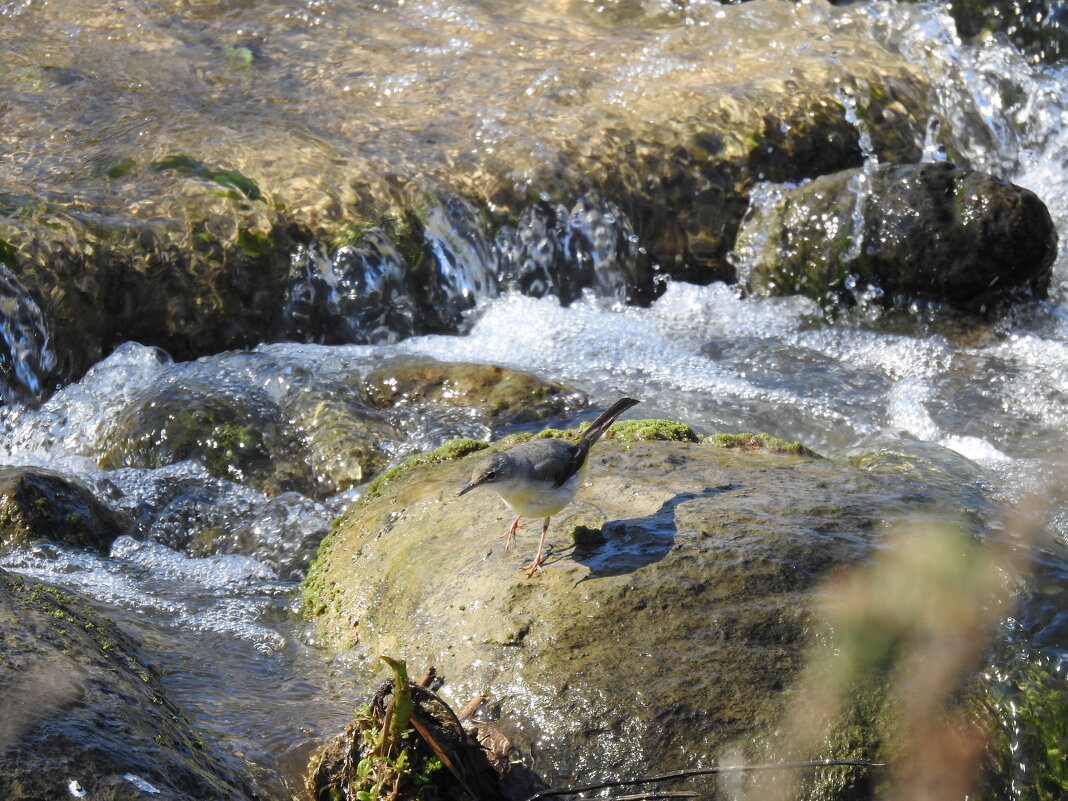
[0,570,283,801]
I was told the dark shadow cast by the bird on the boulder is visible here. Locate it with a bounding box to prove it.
[559,486,737,581]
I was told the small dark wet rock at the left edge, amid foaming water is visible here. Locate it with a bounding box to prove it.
[0,467,134,552]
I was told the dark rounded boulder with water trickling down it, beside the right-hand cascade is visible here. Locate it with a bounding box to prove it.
[736,162,1057,310]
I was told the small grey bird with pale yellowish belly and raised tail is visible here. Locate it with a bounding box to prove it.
[459,397,640,578]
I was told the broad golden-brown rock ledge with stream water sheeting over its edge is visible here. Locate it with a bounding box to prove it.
[0,0,930,393]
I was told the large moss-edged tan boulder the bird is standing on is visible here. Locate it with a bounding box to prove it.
[304,422,983,785]
